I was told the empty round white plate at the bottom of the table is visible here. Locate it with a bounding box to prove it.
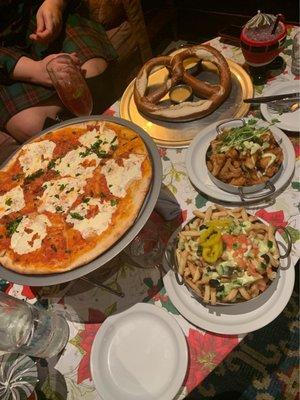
[91,303,188,400]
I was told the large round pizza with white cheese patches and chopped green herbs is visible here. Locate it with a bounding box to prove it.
[0,121,152,274]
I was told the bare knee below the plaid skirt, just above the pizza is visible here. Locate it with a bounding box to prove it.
[6,109,45,142]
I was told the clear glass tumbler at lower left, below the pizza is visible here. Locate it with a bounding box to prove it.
[0,292,69,358]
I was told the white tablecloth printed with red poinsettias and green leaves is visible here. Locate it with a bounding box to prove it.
[0,27,300,400]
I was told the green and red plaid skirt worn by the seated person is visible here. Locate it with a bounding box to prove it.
[0,3,117,129]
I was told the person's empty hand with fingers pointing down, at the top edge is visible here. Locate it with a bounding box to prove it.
[29,0,64,44]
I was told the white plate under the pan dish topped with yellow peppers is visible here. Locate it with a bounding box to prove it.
[163,228,295,335]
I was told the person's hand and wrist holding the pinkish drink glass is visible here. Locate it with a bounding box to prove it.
[12,53,80,87]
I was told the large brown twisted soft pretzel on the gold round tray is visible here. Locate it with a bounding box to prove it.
[134,45,231,121]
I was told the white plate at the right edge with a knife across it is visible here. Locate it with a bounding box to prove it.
[260,81,300,132]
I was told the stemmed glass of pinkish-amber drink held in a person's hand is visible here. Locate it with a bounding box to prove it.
[46,55,93,117]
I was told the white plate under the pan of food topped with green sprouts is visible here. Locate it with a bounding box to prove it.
[185,115,295,204]
